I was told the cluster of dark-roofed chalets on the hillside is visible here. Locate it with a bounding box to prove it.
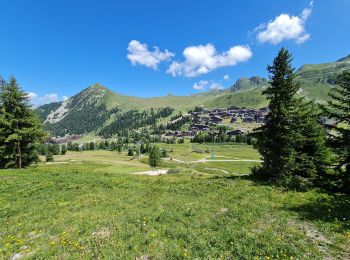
[165,106,269,137]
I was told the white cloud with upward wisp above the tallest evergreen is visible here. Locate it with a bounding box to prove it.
[255,1,313,44]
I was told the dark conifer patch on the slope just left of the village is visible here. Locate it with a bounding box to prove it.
[98,107,174,138]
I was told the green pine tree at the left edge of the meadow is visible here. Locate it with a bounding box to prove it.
[0,77,46,168]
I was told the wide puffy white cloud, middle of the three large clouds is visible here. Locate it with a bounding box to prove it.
[167,43,253,77]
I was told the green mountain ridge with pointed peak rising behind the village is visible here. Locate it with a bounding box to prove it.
[37,55,350,135]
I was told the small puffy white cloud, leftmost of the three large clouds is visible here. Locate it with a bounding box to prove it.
[127,40,175,69]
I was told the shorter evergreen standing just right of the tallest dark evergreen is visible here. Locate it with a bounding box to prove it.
[285,98,329,190]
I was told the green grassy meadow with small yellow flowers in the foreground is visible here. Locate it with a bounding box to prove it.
[0,143,350,259]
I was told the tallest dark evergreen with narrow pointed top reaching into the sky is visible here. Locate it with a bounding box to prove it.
[255,48,299,180]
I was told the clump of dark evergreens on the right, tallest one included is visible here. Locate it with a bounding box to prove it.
[253,48,350,192]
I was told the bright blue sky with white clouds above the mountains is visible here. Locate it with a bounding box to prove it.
[0,0,350,104]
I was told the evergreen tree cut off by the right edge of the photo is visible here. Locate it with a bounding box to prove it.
[326,70,350,192]
